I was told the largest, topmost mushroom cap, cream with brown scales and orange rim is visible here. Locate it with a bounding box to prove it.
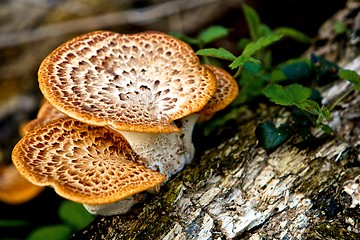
[38,31,216,132]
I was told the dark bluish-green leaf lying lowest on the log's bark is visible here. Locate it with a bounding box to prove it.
[255,121,292,151]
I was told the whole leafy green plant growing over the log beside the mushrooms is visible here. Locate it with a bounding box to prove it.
[174,4,360,150]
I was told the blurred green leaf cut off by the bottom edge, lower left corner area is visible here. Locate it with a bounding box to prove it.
[27,224,72,240]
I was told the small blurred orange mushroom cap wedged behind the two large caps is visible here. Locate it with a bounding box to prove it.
[21,101,68,135]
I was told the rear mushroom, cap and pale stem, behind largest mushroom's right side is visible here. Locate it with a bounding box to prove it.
[179,65,239,163]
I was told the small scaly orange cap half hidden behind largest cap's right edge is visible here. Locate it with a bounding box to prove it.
[199,65,239,115]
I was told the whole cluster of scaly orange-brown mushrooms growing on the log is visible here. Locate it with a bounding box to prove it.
[12,31,238,215]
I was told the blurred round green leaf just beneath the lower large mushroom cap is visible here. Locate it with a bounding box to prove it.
[59,201,94,230]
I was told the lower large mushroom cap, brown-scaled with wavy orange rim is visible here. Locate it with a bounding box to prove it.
[12,118,165,204]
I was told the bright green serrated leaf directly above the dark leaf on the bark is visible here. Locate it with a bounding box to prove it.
[263,84,312,106]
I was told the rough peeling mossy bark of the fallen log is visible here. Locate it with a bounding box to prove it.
[73,1,360,239]
